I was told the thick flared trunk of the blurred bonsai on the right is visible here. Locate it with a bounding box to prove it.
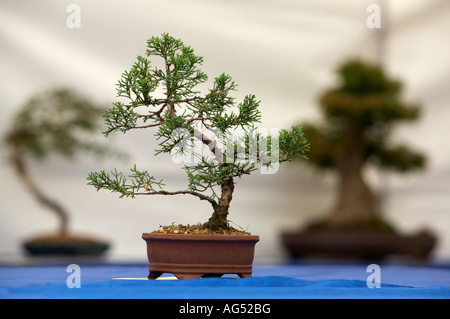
[328,125,378,227]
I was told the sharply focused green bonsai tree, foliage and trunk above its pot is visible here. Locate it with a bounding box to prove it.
[88,34,309,229]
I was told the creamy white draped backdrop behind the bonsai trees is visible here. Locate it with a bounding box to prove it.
[0,0,450,260]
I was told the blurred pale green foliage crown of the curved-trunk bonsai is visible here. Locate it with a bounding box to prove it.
[6,88,108,160]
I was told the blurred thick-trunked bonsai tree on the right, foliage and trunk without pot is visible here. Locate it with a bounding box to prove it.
[303,61,425,227]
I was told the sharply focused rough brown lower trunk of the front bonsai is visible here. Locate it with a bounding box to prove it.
[205,177,234,229]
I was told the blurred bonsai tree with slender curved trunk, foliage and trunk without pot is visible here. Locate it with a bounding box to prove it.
[4,89,112,235]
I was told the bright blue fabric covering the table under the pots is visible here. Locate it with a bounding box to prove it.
[0,264,450,299]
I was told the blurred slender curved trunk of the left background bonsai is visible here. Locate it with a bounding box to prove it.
[10,148,68,236]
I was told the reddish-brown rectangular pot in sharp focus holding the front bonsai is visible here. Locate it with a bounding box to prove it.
[142,233,259,279]
